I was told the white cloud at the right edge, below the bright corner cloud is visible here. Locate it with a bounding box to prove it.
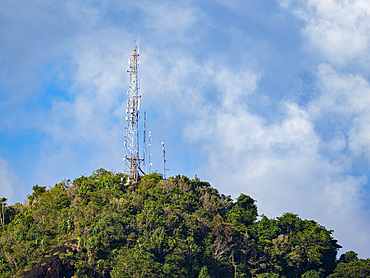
[308,64,370,161]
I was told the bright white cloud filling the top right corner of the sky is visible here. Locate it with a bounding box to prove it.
[282,0,370,66]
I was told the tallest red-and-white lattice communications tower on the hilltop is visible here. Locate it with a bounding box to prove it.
[123,44,142,183]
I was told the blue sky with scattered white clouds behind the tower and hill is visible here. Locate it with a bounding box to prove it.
[0,0,370,257]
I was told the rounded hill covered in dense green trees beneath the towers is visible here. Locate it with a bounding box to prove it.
[0,169,370,278]
